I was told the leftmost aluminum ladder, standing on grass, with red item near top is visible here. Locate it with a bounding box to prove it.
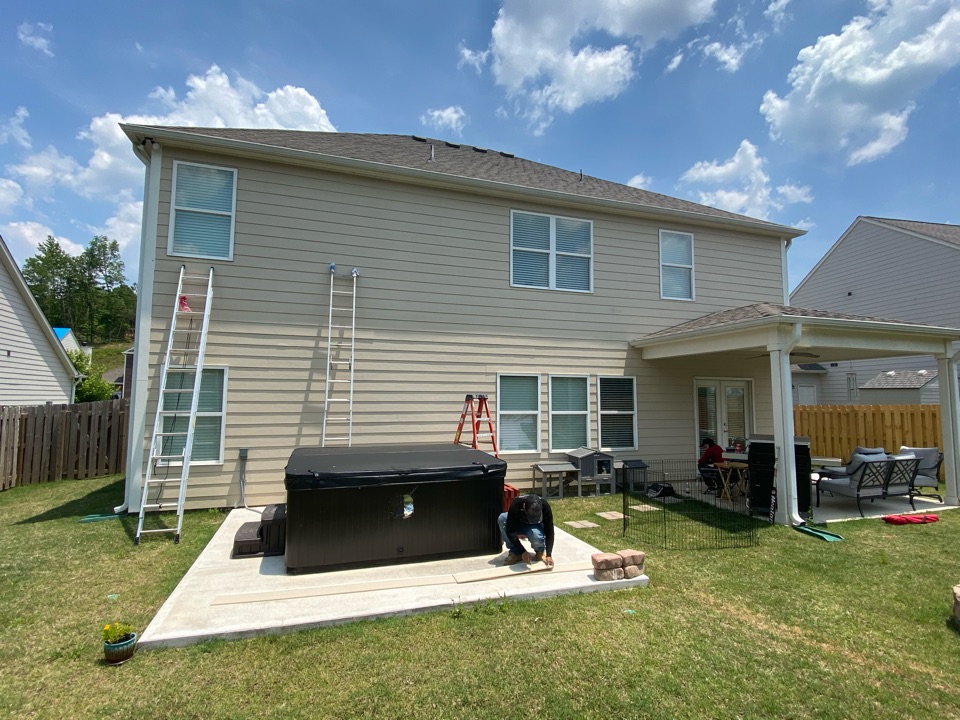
[133,266,213,545]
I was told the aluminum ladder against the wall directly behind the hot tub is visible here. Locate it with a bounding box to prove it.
[320,263,360,447]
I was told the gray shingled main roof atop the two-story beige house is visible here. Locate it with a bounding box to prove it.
[133,126,803,237]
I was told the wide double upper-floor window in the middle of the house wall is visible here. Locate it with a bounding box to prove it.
[510,210,593,292]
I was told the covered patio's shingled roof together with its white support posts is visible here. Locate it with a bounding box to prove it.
[630,303,960,524]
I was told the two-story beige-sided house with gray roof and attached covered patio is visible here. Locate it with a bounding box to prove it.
[122,125,960,522]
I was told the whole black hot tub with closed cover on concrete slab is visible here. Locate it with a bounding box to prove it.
[284,443,507,572]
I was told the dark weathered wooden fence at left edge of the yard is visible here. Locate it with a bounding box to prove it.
[0,399,130,490]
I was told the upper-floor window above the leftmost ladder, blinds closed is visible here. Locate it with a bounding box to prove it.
[167,161,237,260]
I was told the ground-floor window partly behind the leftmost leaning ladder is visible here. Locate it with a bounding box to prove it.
[162,367,227,464]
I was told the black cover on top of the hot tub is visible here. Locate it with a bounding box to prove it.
[284,443,507,490]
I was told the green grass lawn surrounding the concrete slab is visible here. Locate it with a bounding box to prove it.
[0,477,960,720]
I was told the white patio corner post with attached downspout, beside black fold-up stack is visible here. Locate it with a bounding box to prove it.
[770,323,804,525]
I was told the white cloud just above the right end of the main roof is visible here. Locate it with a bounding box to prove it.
[680,140,813,220]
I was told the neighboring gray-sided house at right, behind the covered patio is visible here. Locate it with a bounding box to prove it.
[790,216,960,405]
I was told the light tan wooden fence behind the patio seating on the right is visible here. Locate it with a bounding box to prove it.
[793,405,943,460]
